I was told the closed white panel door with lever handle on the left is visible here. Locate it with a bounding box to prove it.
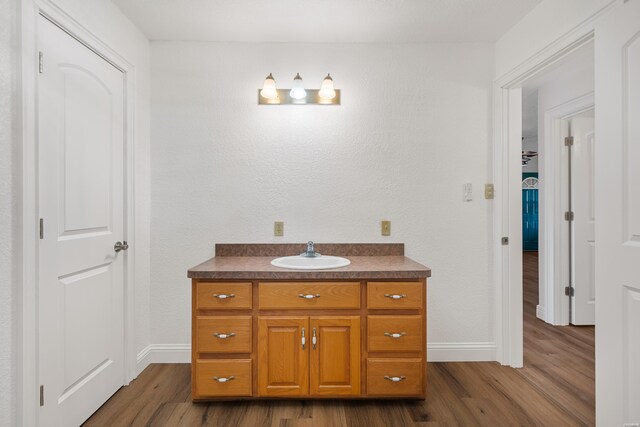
[38,16,126,426]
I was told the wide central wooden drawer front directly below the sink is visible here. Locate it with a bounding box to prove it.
[258,282,360,309]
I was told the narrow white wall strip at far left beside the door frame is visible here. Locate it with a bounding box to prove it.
[0,0,19,426]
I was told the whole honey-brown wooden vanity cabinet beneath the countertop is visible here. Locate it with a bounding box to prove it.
[192,277,426,400]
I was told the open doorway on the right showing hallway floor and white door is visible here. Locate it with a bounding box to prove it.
[521,43,595,424]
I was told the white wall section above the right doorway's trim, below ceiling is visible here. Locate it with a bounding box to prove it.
[495,0,619,77]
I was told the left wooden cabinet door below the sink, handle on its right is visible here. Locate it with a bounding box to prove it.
[258,316,311,396]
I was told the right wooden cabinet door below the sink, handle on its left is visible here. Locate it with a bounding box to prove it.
[307,316,360,396]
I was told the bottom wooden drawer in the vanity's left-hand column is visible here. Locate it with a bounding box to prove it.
[195,359,252,398]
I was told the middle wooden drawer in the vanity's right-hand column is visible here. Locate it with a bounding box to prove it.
[367,315,425,352]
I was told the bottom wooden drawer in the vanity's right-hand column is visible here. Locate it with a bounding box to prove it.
[367,359,425,396]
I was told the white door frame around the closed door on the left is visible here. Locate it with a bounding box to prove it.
[17,0,137,426]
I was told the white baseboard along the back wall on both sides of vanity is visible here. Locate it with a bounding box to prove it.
[136,342,496,375]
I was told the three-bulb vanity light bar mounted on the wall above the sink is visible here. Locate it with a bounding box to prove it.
[258,73,340,105]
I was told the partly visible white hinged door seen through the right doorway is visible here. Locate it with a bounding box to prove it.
[569,110,596,325]
